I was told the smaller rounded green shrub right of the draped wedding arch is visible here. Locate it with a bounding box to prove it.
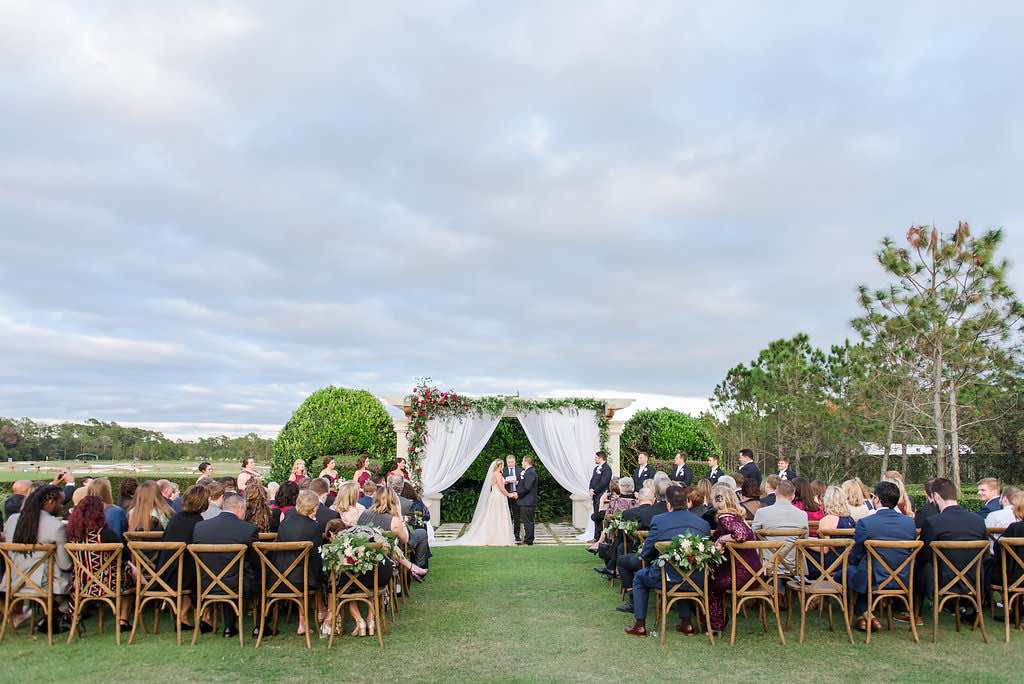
[621,409,719,472]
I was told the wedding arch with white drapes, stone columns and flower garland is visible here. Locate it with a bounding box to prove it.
[387,382,633,528]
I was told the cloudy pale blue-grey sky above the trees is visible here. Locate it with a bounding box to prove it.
[0,0,1024,434]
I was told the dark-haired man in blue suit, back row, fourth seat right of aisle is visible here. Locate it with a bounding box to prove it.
[847,482,918,629]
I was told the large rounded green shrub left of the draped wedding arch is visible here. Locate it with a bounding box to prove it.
[270,387,395,481]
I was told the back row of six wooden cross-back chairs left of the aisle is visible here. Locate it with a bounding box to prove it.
[0,532,411,649]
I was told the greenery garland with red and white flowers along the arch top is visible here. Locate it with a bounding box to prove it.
[406,378,608,480]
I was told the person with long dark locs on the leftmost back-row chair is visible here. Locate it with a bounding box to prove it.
[3,484,72,631]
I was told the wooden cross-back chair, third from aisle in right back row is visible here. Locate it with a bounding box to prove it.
[787,539,853,644]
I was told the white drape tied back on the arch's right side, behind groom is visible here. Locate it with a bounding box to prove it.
[519,409,601,540]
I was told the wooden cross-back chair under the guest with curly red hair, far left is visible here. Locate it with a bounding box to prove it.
[65,542,124,646]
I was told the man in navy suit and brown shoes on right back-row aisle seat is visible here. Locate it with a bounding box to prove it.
[626,485,711,637]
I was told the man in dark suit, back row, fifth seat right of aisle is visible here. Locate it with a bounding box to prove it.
[917,477,988,625]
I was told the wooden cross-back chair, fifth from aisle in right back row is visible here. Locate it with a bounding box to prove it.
[928,540,987,644]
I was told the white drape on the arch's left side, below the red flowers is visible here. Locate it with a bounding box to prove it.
[420,413,501,494]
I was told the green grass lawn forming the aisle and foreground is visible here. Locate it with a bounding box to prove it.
[0,547,1024,684]
